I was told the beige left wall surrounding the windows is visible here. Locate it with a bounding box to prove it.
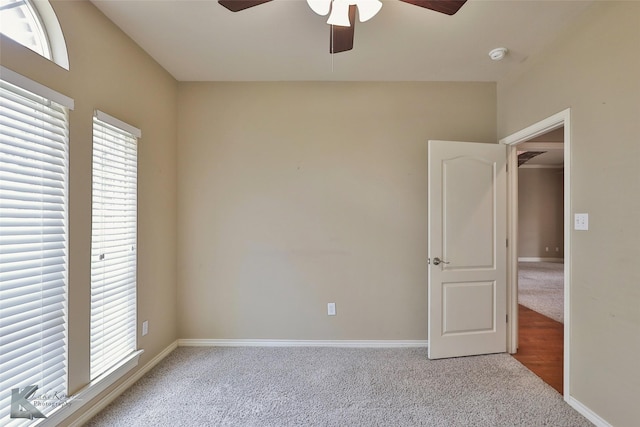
[0,1,178,414]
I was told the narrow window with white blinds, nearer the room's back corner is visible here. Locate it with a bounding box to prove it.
[91,111,141,380]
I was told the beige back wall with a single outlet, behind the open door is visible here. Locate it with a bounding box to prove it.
[178,82,496,340]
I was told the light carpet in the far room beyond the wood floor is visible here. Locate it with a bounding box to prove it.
[518,262,564,323]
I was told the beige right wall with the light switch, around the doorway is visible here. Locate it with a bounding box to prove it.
[498,2,640,426]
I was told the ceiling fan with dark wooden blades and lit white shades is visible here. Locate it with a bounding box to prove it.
[218,0,467,53]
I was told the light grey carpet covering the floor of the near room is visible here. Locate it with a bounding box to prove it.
[88,347,591,427]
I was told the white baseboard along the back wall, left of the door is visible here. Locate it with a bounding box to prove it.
[178,339,428,348]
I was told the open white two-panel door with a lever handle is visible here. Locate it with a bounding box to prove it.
[428,141,507,359]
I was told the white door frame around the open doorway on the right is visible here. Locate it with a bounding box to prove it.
[500,108,572,400]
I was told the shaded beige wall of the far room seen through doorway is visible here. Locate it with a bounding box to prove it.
[518,167,564,258]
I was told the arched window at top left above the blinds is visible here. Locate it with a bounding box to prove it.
[0,0,69,70]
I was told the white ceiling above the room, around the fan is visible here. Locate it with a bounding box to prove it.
[91,0,592,81]
